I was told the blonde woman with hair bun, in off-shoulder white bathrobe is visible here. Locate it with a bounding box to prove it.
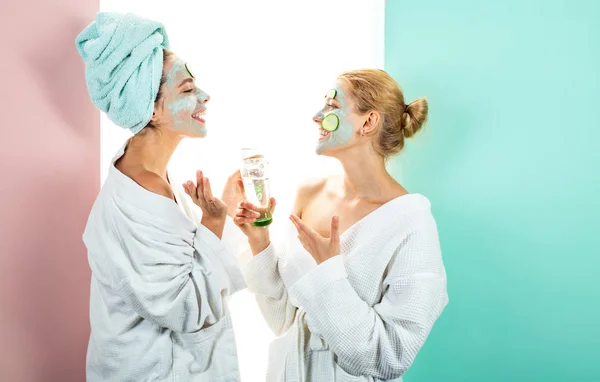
[234,70,448,381]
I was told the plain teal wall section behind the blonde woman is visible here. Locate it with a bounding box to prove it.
[385,0,600,382]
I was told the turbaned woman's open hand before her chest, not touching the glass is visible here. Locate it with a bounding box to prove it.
[183,171,227,239]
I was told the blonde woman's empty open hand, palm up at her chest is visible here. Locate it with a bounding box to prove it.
[290,215,340,264]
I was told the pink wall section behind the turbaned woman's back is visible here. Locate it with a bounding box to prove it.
[0,0,100,382]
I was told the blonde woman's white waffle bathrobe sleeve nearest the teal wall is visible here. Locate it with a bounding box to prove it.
[289,212,448,380]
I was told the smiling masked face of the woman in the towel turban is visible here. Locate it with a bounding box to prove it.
[152,55,210,137]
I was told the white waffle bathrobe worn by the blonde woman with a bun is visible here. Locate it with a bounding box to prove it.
[244,194,448,382]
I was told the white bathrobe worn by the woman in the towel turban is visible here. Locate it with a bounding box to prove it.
[83,145,245,382]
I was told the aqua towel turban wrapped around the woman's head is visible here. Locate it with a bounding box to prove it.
[75,13,169,134]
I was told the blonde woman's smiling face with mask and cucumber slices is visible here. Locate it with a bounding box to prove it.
[313,81,364,155]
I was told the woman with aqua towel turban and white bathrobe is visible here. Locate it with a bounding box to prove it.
[76,13,245,381]
